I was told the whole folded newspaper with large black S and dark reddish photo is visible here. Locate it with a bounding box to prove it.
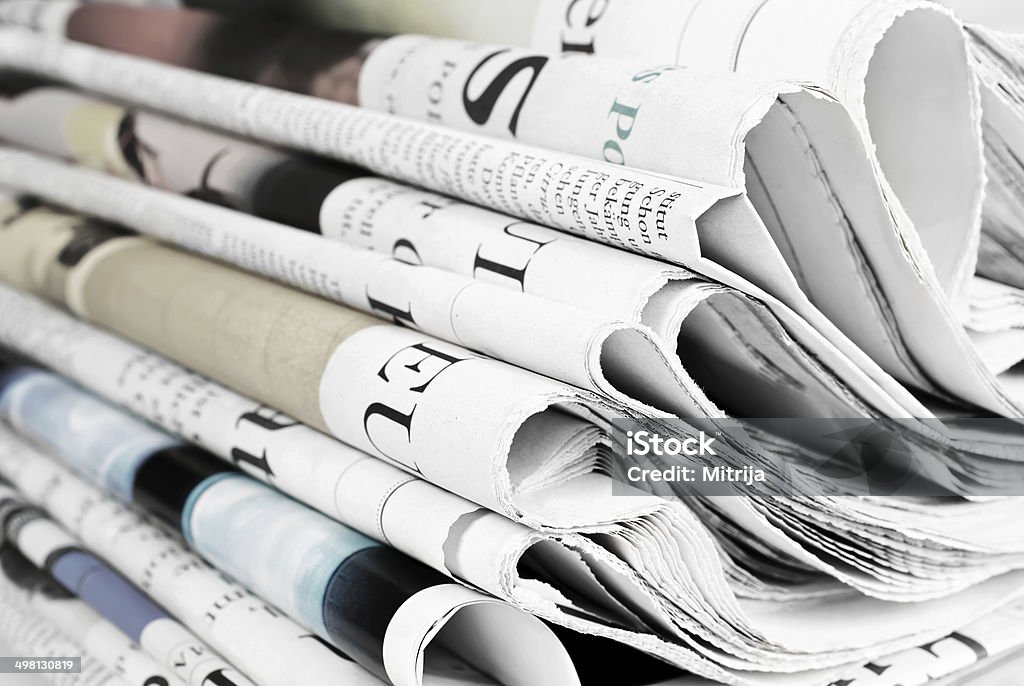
[4,3,1024,412]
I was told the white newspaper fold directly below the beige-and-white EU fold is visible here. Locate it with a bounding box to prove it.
[3,280,651,634]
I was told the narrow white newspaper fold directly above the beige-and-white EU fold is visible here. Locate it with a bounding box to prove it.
[0,145,720,417]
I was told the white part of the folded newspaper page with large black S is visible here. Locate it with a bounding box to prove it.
[359,30,1001,409]
